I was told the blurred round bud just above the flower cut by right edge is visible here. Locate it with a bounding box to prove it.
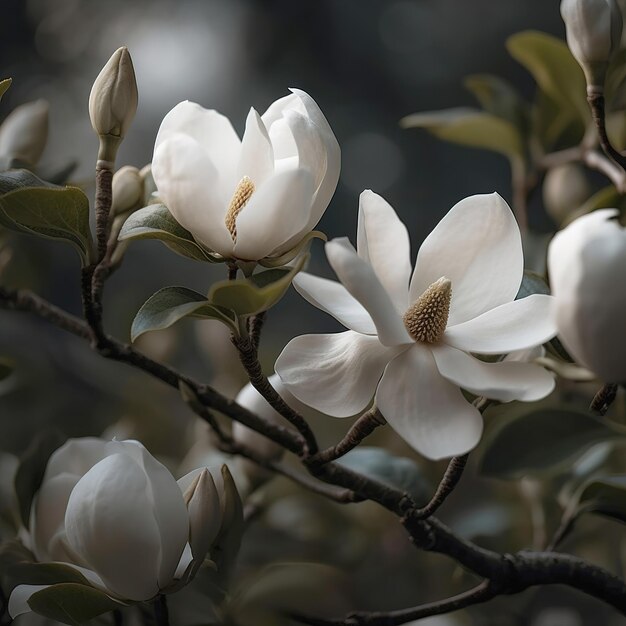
[543,163,591,225]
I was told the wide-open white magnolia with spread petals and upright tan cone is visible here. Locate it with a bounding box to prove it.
[276,191,555,459]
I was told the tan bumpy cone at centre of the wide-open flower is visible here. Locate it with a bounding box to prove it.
[402,277,452,343]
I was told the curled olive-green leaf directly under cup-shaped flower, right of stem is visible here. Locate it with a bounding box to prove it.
[208,254,309,316]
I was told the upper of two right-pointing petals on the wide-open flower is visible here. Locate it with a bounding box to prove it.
[443,294,556,354]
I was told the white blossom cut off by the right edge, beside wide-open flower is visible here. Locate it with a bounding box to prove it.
[548,209,626,383]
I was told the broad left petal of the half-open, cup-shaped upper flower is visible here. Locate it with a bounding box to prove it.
[152,133,233,257]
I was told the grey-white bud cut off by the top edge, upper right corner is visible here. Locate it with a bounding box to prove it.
[561,0,622,93]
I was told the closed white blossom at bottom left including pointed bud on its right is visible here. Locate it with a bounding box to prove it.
[9,438,238,617]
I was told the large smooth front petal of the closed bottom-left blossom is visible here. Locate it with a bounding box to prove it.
[65,454,162,600]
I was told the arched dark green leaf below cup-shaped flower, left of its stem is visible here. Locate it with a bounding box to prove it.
[130,287,237,341]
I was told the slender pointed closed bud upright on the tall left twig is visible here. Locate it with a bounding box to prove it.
[89,47,138,162]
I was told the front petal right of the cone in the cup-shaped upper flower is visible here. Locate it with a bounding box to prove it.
[234,169,313,260]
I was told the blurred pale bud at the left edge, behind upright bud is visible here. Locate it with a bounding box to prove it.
[0,100,49,165]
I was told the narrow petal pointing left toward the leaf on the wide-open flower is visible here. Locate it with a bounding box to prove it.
[293,272,376,335]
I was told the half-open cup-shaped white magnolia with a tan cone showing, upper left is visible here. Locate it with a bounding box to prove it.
[152,89,340,261]
